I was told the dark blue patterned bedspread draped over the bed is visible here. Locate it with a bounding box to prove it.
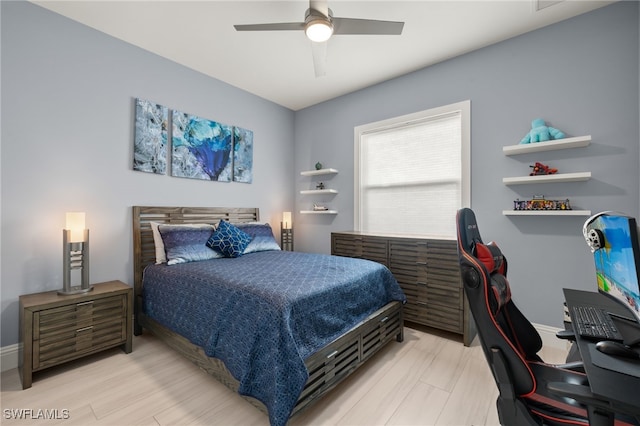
[143,251,405,426]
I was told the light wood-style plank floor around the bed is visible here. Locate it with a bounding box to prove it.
[0,328,566,426]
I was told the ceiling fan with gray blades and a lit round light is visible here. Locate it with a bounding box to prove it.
[234,0,404,77]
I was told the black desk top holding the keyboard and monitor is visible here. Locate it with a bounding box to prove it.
[564,289,640,417]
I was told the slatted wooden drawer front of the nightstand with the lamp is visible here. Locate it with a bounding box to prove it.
[32,295,127,371]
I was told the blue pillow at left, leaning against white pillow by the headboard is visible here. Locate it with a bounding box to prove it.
[158,225,222,265]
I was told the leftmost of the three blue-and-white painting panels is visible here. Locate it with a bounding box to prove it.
[133,99,169,175]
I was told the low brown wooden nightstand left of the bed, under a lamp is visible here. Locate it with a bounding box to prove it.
[20,281,133,389]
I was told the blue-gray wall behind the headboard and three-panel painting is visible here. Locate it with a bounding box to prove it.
[0,1,294,346]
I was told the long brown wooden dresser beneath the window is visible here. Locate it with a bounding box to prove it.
[331,231,476,346]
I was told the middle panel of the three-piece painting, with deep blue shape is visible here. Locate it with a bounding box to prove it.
[171,111,233,182]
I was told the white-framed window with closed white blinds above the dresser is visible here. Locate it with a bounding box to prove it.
[354,101,471,239]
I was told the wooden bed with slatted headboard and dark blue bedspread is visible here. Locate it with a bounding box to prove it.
[133,206,404,426]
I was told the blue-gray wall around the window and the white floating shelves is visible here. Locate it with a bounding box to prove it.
[294,2,640,327]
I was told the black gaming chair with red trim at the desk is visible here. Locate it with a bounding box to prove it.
[456,208,640,426]
